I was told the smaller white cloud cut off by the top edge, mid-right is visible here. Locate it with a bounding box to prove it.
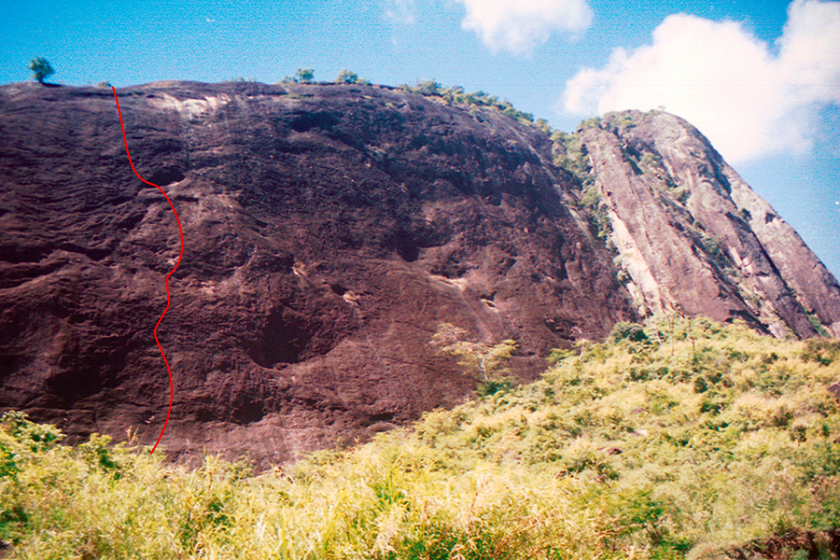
[457,0,592,54]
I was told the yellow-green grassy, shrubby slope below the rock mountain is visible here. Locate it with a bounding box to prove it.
[0,320,840,559]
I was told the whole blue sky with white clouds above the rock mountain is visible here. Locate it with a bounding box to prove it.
[0,0,840,276]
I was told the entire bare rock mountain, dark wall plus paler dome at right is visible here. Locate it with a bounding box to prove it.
[0,82,840,464]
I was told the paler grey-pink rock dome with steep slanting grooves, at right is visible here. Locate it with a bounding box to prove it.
[580,112,840,337]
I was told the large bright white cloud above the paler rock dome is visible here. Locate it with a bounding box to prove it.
[562,0,840,161]
